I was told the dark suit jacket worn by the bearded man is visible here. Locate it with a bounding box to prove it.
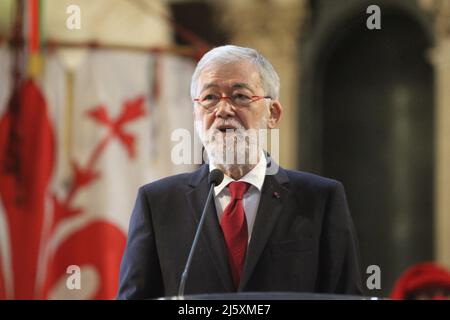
[118,165,362,299]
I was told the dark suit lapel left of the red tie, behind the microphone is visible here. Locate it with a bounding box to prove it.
[186,165,235,292]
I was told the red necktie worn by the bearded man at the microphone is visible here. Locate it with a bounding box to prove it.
[220,182,250,288]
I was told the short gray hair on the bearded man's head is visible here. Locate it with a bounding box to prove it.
[191,45,280,100]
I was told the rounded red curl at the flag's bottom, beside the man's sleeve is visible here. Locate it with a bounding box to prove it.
[44,220,126,299]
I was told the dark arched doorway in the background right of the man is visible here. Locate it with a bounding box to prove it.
[305,3,434,296]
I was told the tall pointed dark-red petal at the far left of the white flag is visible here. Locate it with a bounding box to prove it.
[0,80,54,299]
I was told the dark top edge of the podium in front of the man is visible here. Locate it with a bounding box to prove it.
[158,292,384,300]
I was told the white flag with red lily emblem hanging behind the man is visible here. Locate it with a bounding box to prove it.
[0,49,194,299]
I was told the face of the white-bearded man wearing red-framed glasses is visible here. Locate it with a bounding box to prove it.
[194,62,281,168]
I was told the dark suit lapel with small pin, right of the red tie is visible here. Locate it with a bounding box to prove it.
[238,168,289,291]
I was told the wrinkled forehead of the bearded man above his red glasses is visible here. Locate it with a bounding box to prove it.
[197,62,261,92]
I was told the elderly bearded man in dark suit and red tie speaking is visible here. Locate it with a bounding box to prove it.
[118,45,362,299]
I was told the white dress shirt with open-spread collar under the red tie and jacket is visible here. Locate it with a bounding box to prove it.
[209,152,267,242]
